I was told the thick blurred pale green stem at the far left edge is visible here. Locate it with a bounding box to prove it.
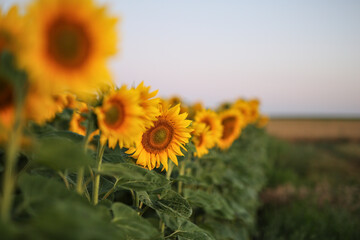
[1,92,24,223]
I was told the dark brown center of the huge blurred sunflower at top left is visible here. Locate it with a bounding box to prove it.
[47,16,91,69]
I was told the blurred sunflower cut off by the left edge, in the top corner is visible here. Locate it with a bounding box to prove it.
[0,6,23,53]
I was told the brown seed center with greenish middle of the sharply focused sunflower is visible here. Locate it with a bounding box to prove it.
[141,119,174,153]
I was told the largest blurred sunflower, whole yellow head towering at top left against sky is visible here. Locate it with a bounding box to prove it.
[19,0,117,97]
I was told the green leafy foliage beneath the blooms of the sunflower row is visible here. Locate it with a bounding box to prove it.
[0,123,267,240]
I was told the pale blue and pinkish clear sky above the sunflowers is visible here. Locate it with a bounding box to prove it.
[0,0,360,117]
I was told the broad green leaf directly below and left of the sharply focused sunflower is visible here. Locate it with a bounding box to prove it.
[99,163,170,191]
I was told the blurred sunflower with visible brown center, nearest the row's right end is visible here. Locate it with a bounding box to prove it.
[218,109,244,149]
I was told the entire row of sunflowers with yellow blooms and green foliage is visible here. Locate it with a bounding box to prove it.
[0,0,268,240]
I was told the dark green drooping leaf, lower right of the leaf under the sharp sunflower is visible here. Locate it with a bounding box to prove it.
[138,190,192,218]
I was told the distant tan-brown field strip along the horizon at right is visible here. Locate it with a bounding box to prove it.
[267,119,360,140]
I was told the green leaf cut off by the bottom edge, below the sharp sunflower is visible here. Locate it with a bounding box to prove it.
[112,203,160,240]
